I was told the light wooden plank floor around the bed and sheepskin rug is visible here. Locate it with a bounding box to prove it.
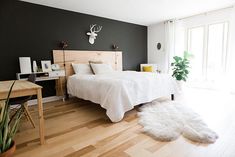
[15,89,235,157]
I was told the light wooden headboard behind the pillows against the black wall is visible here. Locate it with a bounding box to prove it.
[53,50,122,93]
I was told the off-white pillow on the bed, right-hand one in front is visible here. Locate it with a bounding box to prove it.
[90,63,114,74]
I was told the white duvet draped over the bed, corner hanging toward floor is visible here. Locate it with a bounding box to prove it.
[67,71,178,122]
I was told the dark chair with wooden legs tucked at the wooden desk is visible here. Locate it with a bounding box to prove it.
[9,74,36,128]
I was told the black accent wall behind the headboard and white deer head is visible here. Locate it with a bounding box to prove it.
[0,0,147,97]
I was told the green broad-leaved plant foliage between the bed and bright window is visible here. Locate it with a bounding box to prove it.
[171,51,191,81]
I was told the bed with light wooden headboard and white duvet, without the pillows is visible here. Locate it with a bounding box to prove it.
[53,50,177,122]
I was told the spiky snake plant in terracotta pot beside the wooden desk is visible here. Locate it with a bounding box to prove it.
[0,82,23,157]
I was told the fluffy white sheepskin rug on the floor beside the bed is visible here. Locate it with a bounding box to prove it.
[138,101,218,143]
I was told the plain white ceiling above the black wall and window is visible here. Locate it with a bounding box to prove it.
[23,0,235,26]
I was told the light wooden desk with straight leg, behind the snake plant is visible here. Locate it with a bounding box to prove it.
[0,80,45,144]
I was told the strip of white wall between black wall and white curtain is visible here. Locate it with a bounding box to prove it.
[148,22,165,71]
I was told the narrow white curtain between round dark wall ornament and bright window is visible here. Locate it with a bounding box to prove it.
[163,20,175,73]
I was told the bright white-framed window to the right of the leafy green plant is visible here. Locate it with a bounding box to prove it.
[187,22,229,82]
